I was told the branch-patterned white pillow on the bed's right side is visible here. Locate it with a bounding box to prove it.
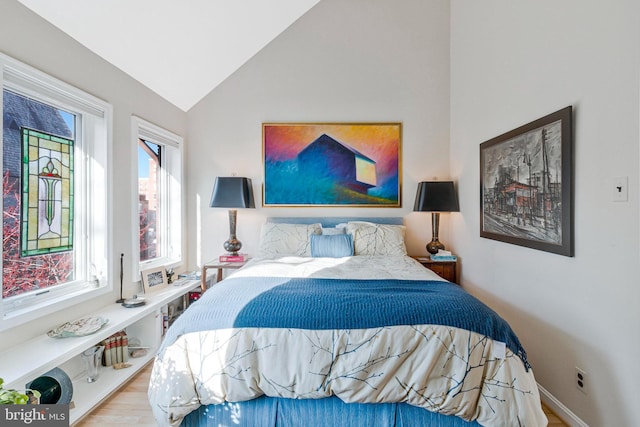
[347,221,407,255]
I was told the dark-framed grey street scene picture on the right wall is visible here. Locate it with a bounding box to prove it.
[480,106,574,257]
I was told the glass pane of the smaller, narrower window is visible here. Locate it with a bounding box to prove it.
[138,139,162,261]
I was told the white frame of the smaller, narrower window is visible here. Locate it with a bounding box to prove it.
[131,116,184,282]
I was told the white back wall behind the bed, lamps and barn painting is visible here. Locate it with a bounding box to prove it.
[187,0,449,266]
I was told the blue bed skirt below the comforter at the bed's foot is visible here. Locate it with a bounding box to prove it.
[181,396,480,427]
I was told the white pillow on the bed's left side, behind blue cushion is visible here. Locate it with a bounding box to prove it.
[258,222,322,258]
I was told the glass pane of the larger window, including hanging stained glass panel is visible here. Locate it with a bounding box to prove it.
[2,90,76,298]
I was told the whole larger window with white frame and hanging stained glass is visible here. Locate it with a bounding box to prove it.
[0,53,113,331]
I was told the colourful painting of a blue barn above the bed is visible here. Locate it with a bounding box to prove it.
[262,123,402,207]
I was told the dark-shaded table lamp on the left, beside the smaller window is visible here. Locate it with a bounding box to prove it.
[209,176,255,255]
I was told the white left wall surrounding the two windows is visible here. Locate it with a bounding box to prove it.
[0,0,186,351]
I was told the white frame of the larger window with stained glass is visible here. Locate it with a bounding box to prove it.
[0,53,113,331]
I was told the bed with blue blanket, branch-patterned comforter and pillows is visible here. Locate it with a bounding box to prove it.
[148,218,547,427]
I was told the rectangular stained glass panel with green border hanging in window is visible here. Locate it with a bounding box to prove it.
[20,128,73,256]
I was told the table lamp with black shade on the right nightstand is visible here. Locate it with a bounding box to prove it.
[413,181,460,254]
